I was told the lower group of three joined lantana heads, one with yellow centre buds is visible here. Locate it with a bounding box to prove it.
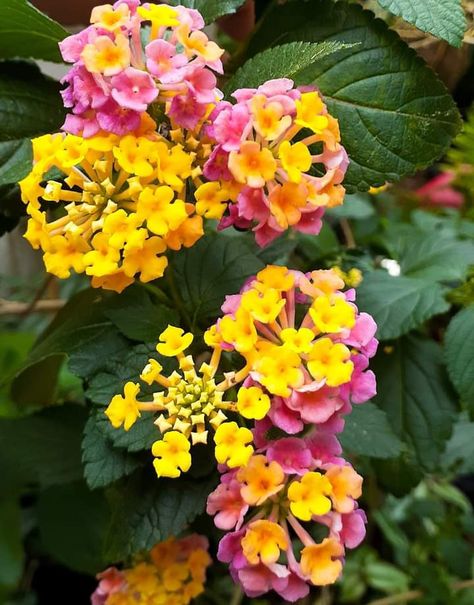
[106,265,378,601]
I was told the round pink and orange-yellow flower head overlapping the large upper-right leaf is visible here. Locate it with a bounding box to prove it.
[203,78,348,246]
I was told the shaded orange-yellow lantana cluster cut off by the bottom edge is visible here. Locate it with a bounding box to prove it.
[91,534,211,605]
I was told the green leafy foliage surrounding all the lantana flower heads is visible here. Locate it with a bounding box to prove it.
[0,0,474,605]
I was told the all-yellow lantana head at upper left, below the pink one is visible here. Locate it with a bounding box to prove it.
[20,130,203,292]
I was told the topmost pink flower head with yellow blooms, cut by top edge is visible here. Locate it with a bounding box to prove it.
[60,0,224,137]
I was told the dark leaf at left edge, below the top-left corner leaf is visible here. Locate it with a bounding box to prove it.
[0,61,64,185]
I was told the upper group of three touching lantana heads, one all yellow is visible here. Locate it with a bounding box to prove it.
[21,0,348,291]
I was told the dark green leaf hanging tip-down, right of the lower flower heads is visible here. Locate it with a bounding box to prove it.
[372,336,456,470]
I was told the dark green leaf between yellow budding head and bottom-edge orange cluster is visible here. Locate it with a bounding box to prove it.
[106,473,217,560]
